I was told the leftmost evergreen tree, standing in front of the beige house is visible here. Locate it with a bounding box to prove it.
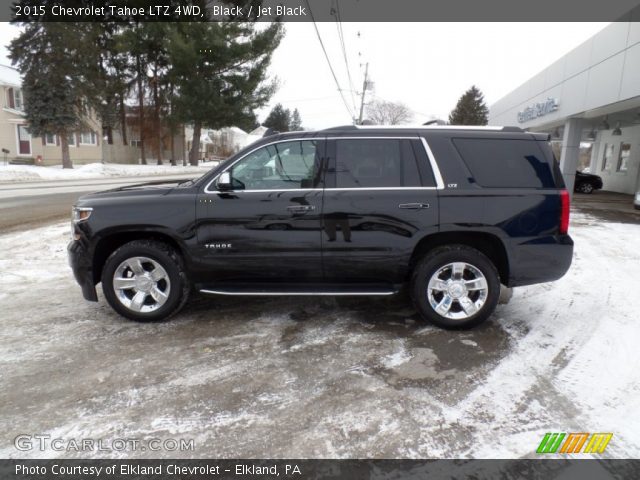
[9,22,88,168]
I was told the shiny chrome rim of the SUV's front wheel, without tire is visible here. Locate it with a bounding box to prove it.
[113,257,171,313]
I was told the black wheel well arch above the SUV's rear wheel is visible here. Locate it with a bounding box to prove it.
[409,231,509,285]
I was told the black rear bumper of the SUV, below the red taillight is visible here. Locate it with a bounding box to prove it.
[508,235,573,287]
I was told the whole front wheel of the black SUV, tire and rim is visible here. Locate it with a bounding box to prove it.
[102,240,189,321]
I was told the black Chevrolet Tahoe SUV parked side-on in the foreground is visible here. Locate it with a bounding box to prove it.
[68,126,573,328]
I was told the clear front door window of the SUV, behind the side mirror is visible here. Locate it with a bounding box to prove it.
[229,140,319,190]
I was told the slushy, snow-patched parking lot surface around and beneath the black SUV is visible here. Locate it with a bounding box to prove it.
[0,213,640,458]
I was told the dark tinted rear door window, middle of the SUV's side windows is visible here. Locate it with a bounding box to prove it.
[336,139,421,188]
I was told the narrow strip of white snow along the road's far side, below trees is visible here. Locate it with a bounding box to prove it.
[0,162,215,182]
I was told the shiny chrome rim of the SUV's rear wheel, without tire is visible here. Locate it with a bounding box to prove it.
[427,262,489,320]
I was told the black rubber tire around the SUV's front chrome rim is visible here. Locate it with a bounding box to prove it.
[101,240,190,322]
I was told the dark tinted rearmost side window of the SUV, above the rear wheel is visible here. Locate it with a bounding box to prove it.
[453,138,555,188]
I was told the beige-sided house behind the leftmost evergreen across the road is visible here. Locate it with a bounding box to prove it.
[0,65,103,165]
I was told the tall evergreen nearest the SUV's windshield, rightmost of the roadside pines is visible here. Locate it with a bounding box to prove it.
[168,21,283,165]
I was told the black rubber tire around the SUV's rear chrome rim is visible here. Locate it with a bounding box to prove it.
[411,245,500,329]
